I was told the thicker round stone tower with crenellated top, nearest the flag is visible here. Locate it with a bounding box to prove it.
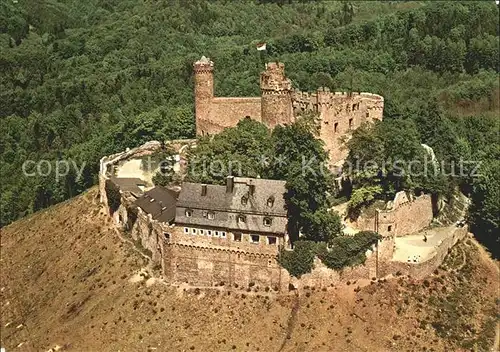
[260,62,293,128]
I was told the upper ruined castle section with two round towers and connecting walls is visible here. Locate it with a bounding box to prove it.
[193,56,384,165]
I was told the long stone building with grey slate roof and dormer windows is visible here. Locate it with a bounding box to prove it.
[162,176,288,287]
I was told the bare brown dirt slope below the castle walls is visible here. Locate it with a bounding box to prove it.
[0,189,499,352]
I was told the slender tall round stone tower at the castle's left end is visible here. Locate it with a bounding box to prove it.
[193,56,214,135]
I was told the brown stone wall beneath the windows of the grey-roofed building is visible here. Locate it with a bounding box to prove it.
[162,225,288,288]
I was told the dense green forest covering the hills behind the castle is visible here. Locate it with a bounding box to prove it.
[0,0,500,256]
